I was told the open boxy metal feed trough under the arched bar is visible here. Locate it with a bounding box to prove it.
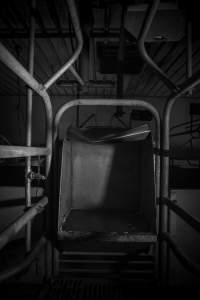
[55,102,158,250]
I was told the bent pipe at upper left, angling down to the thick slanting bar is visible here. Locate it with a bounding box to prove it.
[44,0,83,89]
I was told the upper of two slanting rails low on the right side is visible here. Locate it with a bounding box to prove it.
[162,199,200,233]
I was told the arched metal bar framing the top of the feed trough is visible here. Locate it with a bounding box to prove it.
[54,99,161,202]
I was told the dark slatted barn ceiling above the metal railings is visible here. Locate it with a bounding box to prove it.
[0,0,200,97]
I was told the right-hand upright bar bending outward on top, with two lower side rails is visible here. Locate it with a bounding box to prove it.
[160,71,200,280]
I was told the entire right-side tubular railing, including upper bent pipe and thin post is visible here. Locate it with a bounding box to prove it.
[138,0,200,283]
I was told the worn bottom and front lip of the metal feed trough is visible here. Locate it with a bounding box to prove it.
[59,210,157,243]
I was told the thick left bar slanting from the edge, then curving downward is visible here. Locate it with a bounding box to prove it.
[0,43,53,176]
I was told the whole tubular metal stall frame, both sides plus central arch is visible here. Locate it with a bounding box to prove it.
[0,0,200,286]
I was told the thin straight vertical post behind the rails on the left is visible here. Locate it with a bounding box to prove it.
[25,0,35,252]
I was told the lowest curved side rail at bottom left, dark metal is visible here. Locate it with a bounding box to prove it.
[0,237,47,282]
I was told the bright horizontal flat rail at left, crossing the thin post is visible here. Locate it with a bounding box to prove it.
[0,146,50,158]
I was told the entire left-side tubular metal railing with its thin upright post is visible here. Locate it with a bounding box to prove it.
[0,0,83,281]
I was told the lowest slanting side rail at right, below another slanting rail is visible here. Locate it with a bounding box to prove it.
[162,233,200,277]
